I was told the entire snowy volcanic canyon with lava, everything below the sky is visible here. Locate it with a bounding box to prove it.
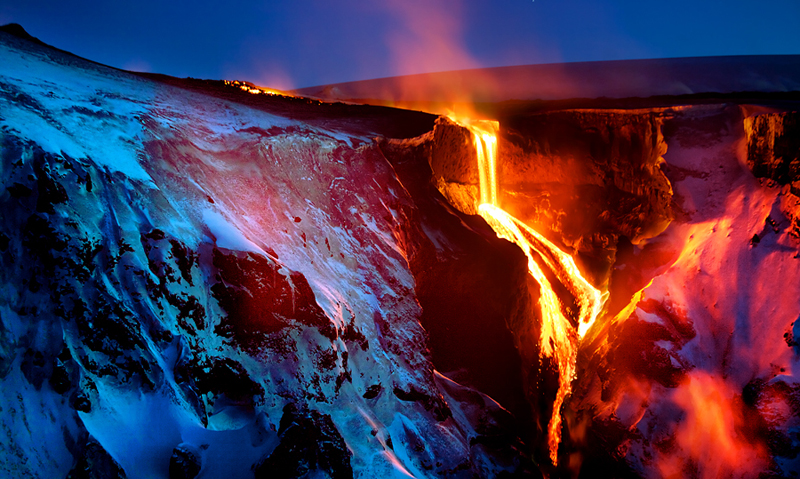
[0,26,800,478]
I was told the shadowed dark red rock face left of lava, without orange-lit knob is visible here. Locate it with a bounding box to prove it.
[380,134,538,435]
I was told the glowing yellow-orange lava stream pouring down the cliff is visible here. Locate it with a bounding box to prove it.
[466,121,605,465]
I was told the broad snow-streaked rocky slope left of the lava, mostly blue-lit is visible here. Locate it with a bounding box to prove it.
[0,33,536,478]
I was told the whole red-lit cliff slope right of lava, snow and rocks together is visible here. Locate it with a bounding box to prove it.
[568,105,800,477]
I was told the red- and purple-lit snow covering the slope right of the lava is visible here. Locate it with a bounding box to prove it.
[604,106,800,477]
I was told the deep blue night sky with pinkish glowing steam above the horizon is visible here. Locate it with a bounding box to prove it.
[0,0,800,89]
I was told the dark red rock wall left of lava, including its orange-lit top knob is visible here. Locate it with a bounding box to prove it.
[382,131,592,461]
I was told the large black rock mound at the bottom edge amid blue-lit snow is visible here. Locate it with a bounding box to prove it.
[255,404,353,479]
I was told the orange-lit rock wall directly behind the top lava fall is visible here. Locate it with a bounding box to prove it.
[431,110,672,284]
